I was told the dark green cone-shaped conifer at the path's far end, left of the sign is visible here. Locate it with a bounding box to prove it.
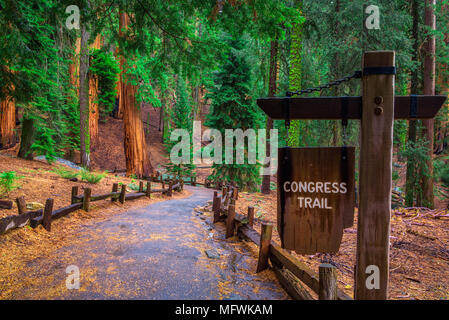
[206,39,263,191]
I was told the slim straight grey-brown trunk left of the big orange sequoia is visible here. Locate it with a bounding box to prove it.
[79,24,90,168]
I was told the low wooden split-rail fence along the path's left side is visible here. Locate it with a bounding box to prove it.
[0,180,184,234]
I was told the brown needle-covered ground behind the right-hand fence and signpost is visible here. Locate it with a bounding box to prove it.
[236,192,449,300]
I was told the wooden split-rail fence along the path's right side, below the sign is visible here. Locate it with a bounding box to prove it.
[212,185,352,300]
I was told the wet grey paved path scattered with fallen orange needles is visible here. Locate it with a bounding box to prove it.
[14,187,288,300]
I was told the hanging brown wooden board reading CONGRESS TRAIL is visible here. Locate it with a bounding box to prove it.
[277,147,355,255]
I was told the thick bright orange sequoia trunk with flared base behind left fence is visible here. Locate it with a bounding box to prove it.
[120,12,152,177]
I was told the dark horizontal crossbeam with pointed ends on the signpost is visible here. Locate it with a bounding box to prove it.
[257,96,446,120]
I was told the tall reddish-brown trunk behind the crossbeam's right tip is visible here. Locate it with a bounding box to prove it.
[422,0,436,208]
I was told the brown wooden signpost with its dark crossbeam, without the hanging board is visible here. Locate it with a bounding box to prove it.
[257,51,446,299]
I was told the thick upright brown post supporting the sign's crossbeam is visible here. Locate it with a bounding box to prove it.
[354,51,395,300]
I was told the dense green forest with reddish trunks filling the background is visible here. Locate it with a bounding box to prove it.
[0,0,449,207]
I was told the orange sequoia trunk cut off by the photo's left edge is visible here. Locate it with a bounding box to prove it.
[0,92,16,148]
